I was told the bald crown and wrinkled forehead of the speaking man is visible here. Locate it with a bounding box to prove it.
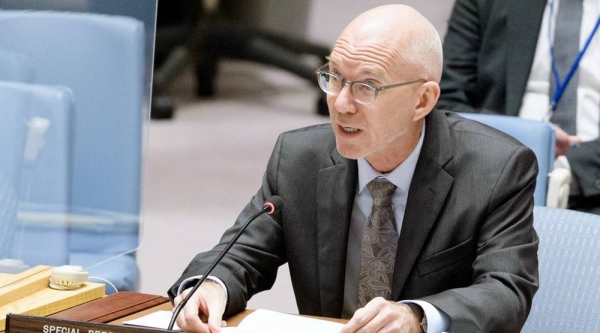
[331,5,442,82]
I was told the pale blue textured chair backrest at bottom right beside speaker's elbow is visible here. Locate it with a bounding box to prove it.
[522,207,600,333]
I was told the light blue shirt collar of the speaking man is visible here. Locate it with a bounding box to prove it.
[357,122,425,193]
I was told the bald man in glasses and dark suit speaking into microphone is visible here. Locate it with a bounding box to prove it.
[169,5,538,333]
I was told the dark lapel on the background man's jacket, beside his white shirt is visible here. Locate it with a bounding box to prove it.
[506,0,546,116]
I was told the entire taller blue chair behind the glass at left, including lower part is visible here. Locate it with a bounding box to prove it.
[0,10,144,291]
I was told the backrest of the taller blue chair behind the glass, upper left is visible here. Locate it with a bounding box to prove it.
[0,10,144,214]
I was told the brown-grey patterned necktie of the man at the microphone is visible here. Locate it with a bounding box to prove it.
[358,178,398,307]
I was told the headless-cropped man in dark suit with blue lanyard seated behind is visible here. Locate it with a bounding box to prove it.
[437,0,600,214]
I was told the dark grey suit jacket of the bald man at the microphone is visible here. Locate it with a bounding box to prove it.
[169,110,538,333]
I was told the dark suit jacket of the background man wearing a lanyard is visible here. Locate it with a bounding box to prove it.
[437,0,600,214]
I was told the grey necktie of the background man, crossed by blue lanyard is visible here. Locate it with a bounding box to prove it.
[549,0,583,135]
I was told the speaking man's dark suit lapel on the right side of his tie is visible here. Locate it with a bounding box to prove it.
[392,110,453,300]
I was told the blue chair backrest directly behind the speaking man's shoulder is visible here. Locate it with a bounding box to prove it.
[460,113,555,206]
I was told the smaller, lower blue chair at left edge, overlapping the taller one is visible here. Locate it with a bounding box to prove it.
[0,81,74,266]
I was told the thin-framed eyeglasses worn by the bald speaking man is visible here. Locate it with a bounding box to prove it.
[315,63,427,105]
